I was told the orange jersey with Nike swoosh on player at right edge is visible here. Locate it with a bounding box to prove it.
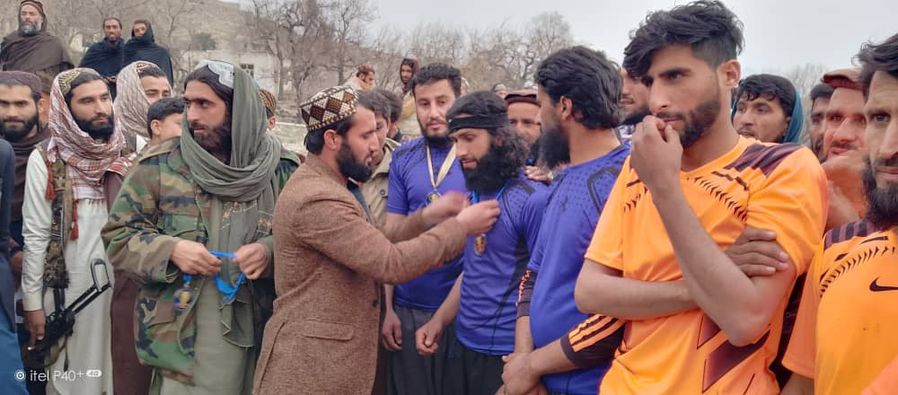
[783,221,898,394]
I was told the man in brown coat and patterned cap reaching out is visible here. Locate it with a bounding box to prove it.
[254,87,499,394]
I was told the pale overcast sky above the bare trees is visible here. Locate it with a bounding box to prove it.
[371,0,898,74]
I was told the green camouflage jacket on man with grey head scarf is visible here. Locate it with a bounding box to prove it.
[103,139,299,382]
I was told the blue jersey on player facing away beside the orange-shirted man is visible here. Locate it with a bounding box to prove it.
[528,143,630,394]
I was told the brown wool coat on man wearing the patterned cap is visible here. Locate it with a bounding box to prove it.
[253,155,466,394]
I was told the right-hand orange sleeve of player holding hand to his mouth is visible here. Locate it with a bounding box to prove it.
[746,149,827,276]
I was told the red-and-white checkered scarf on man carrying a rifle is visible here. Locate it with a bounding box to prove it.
[47,68,125,201]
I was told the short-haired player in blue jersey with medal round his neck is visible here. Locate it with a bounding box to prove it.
[381,63,465,394]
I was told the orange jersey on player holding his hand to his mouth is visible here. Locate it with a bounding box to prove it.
[586,137,826,394]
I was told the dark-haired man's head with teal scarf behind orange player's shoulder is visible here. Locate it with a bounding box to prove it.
[733,74,804,144]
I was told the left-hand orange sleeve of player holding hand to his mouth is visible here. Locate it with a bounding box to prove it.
[586,158,635,271]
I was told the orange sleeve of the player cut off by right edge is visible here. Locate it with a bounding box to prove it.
[783,242,824,378]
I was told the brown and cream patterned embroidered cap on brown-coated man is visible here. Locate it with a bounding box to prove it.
[299,86,358,130]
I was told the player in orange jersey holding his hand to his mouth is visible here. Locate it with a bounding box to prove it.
[576,1,826,394]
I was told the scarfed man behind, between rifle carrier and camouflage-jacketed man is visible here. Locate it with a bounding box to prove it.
[104,61,171,395]
